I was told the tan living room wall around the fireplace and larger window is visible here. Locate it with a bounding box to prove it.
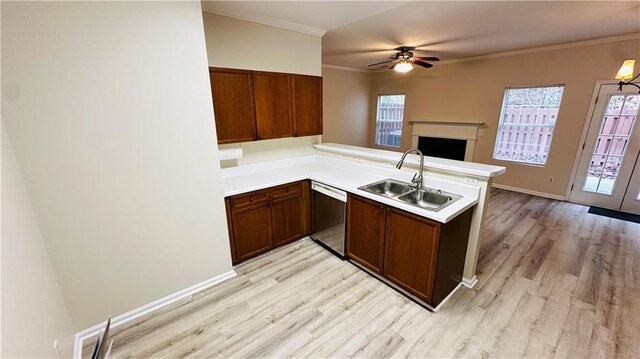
[369,40,640,196]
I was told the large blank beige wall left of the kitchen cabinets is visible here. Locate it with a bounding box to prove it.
[2,1,231,332]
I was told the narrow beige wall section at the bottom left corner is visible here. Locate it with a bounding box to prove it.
[0,128,73,358]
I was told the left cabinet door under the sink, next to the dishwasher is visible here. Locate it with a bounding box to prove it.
[347,195,386,274]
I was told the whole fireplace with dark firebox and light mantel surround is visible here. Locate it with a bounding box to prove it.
[409,121,484,161]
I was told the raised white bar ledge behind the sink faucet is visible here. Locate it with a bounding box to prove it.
[313,143,506,178]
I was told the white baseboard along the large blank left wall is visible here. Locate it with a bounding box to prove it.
[73,269,236,359]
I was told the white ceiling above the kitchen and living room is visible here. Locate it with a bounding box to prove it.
[203,1,640,68]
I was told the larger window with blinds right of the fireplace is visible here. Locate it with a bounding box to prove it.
[493,86,564,166]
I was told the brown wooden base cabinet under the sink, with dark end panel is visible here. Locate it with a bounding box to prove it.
[347,195,473,306]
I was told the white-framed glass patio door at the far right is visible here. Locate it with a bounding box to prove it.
[570,84,640,213]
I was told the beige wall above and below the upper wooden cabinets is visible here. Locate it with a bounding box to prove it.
[203,13,322,166]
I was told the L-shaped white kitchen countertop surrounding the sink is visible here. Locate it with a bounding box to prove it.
[222,154,480,223]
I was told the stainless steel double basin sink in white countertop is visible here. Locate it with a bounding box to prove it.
[358,179,462,212]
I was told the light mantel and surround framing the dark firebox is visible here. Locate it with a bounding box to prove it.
[409,120,484,161]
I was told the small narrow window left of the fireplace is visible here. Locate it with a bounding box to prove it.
[376,95,404,147]
